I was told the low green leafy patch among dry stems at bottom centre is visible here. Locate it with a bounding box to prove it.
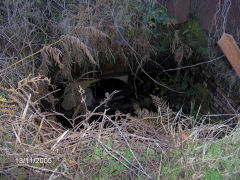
[83,140,172,179]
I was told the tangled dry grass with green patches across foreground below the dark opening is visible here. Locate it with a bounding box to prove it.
[0,79,240,179]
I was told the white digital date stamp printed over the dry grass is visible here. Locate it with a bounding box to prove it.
[16,157,52,164]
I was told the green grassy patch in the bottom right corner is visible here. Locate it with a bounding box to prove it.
[185,133,240,180]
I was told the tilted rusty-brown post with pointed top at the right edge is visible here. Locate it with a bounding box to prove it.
[218,33,240,77]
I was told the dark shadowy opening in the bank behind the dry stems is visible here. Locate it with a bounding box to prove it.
[39,66,236,128]
